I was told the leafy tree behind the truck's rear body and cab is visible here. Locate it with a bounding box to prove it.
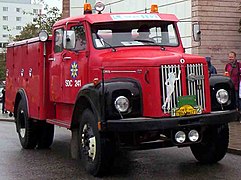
[13,1,62,41]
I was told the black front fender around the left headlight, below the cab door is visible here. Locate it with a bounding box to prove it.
[71,78,143,128]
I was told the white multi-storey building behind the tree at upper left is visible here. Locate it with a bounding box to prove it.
[0,0,42,52]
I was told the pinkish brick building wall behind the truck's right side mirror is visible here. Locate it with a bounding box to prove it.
[192,0,241,73]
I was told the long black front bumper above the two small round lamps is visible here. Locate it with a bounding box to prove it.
[105,110,239,132]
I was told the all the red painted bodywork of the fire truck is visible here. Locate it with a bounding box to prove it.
[6,13,211,128]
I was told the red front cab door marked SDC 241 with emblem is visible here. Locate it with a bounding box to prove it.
[62,23,88,104]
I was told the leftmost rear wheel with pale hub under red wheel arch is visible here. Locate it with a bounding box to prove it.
[16,99,37,149]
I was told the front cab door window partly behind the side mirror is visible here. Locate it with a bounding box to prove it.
[71,25,86,51]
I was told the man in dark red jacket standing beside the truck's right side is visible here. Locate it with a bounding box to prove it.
[225,51,241,110]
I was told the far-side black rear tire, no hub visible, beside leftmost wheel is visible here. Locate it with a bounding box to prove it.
[37,122,54,149]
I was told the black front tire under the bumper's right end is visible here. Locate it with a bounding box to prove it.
[191,124,229,164]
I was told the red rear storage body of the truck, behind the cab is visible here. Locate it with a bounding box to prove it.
[6,38,54,120]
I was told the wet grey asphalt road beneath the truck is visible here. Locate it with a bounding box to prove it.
[0,122,241,180]
